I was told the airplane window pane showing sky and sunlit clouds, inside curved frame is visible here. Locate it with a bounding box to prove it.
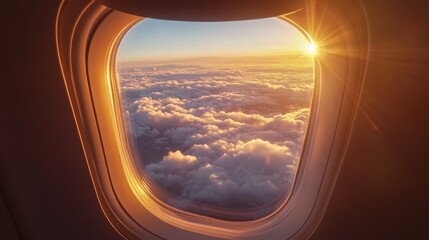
[116,18,316,221]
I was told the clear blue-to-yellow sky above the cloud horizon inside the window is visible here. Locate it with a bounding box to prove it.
[117,18,309,62]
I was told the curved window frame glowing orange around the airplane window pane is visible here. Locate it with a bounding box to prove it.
[57,1,367,239]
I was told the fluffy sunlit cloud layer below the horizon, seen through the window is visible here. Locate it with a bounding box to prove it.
[119,61,313,218]
